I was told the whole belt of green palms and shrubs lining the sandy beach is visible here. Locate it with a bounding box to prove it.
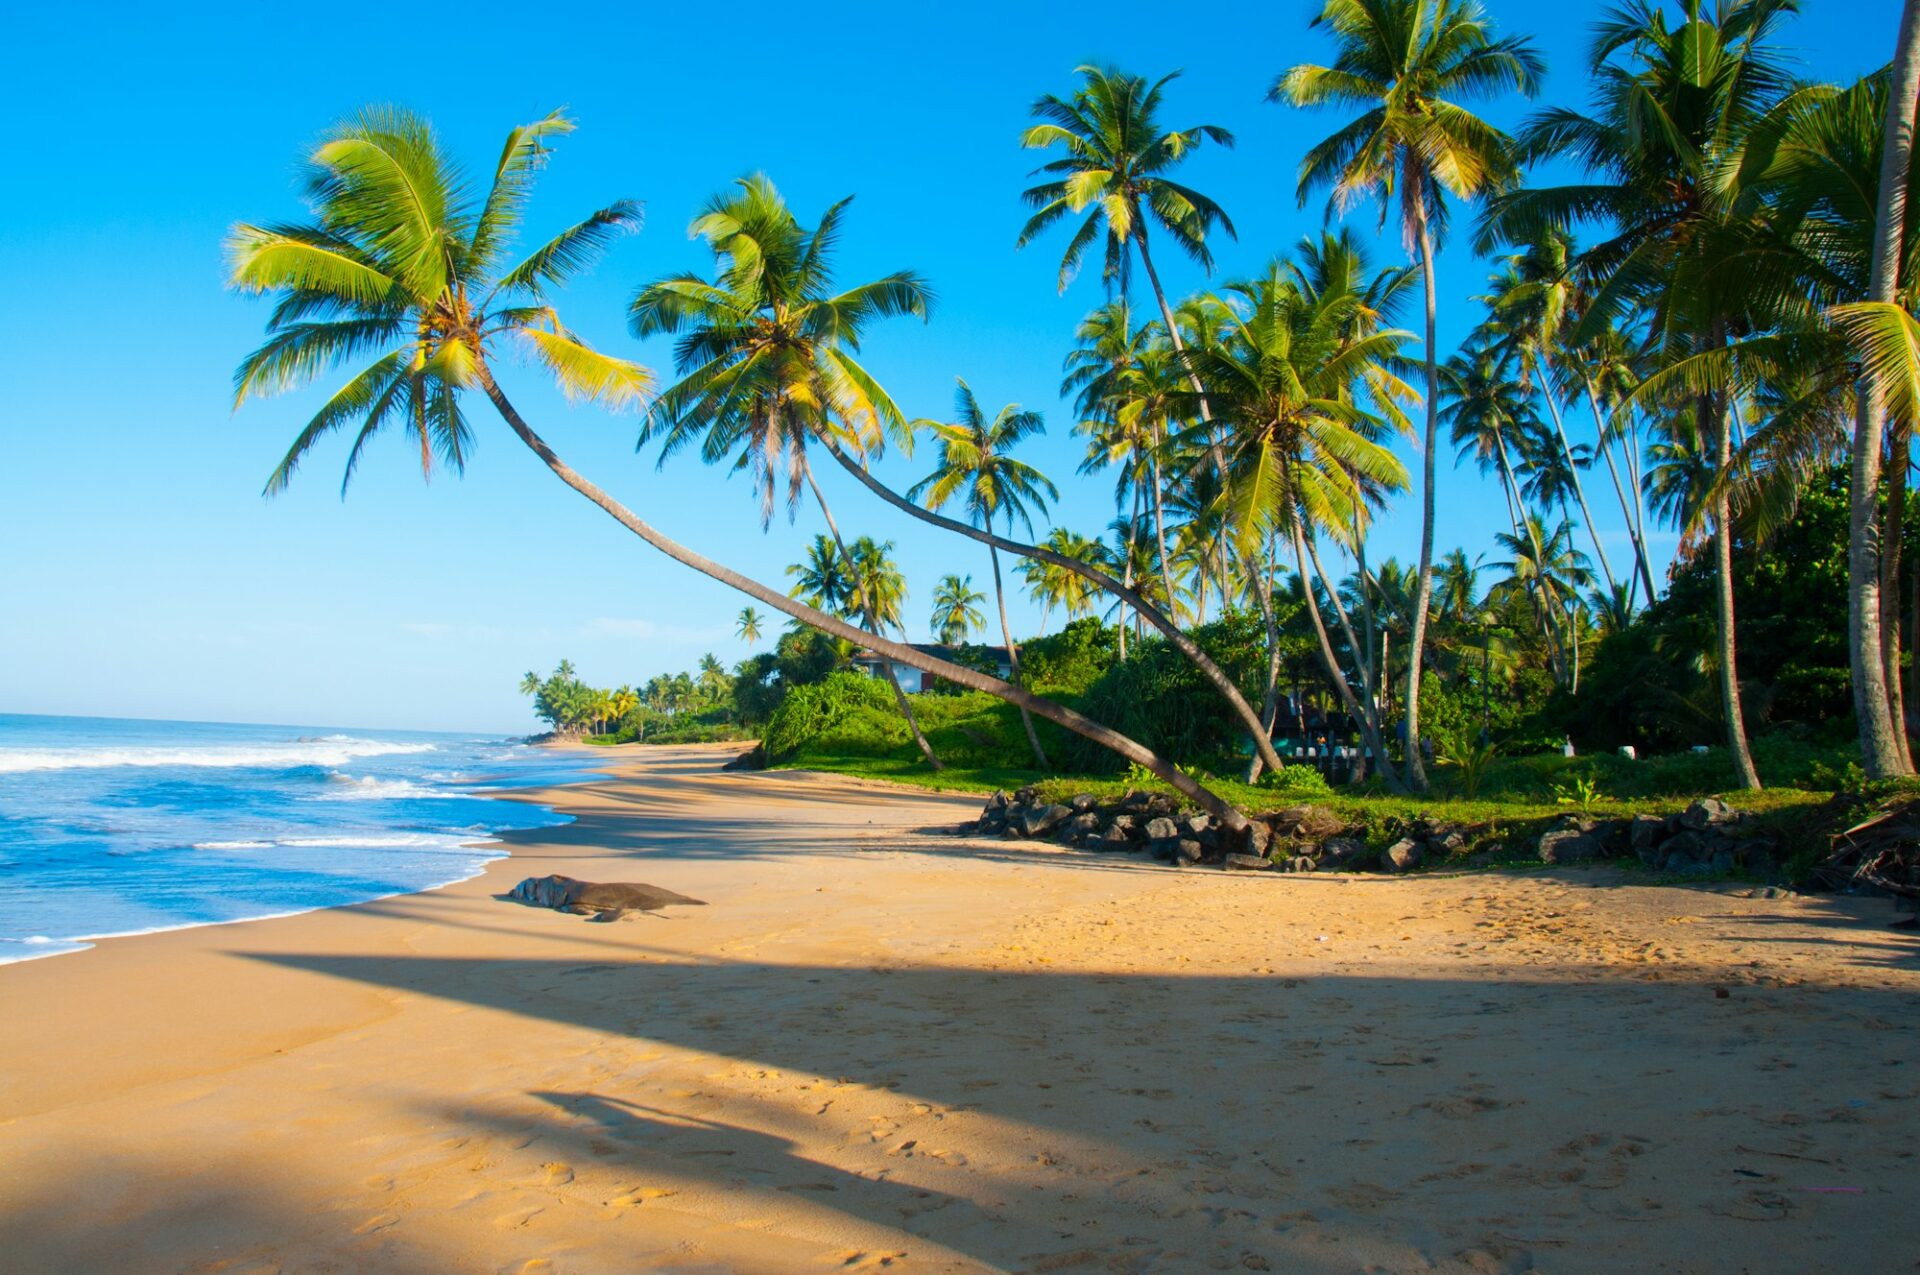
[240,0,1920,831]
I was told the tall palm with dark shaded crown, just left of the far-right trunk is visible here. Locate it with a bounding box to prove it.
[1480,0,1807,787]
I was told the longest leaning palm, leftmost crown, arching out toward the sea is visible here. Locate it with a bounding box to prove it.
[228,111,1248,831]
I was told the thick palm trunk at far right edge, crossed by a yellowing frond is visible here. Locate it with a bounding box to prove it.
[1847,0,1920,778]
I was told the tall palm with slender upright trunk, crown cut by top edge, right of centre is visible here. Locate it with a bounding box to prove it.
[1267,0,1542,789]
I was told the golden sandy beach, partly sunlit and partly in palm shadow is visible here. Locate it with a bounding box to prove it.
[0,749,1920,1275]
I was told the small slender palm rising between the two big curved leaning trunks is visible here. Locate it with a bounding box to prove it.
[908,380,1060,770]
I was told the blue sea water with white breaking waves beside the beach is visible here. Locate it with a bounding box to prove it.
[0,714,593,964]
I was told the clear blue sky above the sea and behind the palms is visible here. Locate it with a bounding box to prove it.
[0,0,1899,730]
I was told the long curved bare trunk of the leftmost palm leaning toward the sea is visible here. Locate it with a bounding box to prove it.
[474,363,1248,833]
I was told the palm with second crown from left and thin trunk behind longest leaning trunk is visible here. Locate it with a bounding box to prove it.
[628,175,941,770]
